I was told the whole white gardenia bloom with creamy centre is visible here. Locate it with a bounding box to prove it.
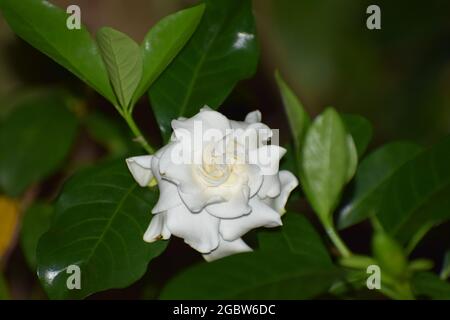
[127,107,298,261]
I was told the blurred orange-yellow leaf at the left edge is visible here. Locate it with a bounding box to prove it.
[0,196,19,258]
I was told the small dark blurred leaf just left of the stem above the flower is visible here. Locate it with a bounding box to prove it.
[83,111,134,156]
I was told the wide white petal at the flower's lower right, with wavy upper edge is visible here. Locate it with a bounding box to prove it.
[219,197,282,241]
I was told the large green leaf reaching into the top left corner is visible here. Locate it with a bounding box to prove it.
[0,0,116,104]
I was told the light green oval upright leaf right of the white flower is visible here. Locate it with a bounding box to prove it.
[300,108,351,222]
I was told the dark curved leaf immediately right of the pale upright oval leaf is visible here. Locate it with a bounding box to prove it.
[338,142,421,229]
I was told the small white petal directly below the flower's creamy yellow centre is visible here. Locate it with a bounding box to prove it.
[205,186,252,219]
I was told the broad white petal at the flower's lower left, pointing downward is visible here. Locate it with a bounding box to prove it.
[166,205,219,253]
